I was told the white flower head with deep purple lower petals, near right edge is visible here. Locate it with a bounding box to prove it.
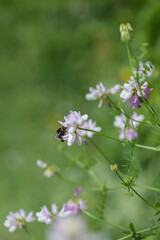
[120,77,153,109]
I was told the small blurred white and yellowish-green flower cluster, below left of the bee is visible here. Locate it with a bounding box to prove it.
[37,160,60,178]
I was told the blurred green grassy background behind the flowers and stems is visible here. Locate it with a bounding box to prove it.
[0,0,160,240]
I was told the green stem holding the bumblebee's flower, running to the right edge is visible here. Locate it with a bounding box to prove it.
[78,128,160,152]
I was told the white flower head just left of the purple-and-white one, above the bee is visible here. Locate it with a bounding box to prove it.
[86,82,120,107]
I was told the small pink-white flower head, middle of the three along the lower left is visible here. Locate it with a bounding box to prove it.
[36,203,58,224]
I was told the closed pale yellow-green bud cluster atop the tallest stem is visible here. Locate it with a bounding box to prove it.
[119,23,133,42]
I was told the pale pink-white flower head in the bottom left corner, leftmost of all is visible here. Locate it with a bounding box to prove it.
[4,209,35,232]
